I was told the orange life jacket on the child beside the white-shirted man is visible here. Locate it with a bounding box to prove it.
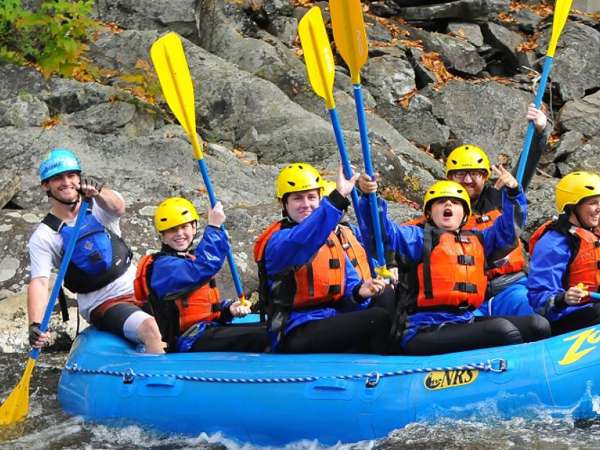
[133,253,221,333]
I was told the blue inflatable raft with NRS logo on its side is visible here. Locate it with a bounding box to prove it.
[58,326,600,446]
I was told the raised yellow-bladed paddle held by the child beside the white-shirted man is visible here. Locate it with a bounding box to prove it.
[150,32,247,304]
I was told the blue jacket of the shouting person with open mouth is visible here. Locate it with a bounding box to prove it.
[359,188,527,346]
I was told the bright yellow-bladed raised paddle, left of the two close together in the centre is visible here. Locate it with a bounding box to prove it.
[298,6,373,272]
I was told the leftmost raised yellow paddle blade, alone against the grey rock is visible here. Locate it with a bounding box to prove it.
[150,32,202,159]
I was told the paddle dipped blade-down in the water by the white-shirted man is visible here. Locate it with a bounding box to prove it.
[0,199,89,425]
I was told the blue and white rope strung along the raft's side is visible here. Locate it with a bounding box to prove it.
[65,358,508,387]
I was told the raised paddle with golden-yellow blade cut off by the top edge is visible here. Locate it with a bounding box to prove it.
[329,0,391,278]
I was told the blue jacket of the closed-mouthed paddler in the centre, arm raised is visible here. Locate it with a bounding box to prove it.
[264,197,368,334]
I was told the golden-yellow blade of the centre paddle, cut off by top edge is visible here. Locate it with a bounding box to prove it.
[329,0,369,84]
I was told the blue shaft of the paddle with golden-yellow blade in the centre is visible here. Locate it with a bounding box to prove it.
[353,84,385,267]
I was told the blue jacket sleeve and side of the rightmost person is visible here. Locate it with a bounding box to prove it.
[527,230,592,322]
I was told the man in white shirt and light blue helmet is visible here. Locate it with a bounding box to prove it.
[27,149,164,353]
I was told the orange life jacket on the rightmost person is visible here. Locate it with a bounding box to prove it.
[529,220,600,292]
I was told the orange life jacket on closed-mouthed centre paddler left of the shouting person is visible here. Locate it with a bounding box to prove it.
[254,221,346,309]
